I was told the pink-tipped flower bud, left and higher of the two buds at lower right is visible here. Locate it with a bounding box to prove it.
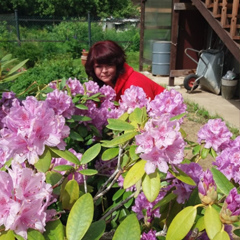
[198,170,217,205]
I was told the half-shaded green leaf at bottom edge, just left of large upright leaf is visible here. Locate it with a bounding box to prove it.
[43,219,64,240]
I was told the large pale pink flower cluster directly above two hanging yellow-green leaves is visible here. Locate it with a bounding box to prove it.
[135,114,185,174]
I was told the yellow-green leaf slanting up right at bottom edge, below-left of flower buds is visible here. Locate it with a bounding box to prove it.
[166,206,197,240]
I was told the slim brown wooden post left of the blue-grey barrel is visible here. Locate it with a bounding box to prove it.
[139,0,146,71]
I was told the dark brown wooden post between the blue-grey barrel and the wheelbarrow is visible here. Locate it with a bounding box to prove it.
[168,0,180,86]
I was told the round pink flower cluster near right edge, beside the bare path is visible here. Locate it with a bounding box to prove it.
[198,119,232,152]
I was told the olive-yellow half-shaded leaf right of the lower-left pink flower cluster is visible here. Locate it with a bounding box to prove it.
[61,179,79,210]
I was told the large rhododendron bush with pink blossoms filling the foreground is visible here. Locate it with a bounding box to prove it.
[0,79,240,240]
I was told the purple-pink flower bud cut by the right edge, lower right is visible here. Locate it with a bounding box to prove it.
[220,188,240,224]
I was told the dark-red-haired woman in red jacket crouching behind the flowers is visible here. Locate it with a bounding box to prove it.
[85,40,164,101]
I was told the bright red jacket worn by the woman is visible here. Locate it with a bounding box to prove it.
[114,63,165,101]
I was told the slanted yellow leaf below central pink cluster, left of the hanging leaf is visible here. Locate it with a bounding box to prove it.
[123,160,147,189]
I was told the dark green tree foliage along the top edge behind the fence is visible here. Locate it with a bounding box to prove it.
[0,0,139,18]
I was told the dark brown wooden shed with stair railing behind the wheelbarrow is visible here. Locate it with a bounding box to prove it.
[139,0,240,86]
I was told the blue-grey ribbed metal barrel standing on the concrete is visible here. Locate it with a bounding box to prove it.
[152,41,171,75]
